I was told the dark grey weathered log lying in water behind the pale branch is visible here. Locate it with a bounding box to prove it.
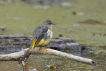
[0,34,87,54]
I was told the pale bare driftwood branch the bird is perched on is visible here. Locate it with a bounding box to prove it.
[0,47,95,65]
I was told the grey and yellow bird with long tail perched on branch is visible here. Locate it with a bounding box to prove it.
[19,19,55,64]
